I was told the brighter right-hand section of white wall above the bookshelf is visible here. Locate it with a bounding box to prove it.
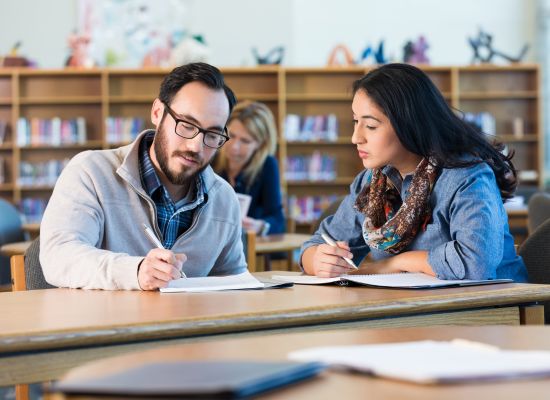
[291,0,536,65]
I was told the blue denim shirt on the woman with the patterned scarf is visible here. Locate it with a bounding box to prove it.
[302,163,527,282]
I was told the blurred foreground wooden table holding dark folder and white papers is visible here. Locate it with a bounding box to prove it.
[44,326,550,400]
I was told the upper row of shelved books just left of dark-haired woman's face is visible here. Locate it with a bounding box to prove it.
[284,114,338,142]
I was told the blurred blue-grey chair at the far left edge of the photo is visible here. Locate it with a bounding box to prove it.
[0,199,25,285]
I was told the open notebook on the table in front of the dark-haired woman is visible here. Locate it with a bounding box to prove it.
[271,272,513,289]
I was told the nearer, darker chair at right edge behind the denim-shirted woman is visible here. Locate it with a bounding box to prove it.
[519,220,550,323]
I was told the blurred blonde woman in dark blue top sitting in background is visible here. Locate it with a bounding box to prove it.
[214,101,285,235]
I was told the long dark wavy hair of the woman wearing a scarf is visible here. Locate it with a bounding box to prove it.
[353,63,518,201]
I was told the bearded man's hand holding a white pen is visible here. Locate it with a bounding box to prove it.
[138,248,187,290]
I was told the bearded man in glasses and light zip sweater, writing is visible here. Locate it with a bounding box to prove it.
[40,63,246,290]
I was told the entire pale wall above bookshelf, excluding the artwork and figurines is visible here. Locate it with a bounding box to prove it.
[0,0,537,67]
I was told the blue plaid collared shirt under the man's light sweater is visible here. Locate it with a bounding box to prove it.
[139,132,205,249]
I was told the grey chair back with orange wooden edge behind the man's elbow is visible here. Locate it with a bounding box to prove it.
[11,236,55,291]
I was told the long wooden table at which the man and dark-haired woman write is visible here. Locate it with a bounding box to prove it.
[0,273,550,356]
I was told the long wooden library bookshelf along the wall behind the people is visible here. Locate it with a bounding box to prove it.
[0,64,543,236]
